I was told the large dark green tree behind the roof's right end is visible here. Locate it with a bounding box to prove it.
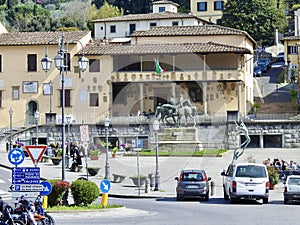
[222,0,287,46]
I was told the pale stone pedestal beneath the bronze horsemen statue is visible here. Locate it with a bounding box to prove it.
[158,127,203,152]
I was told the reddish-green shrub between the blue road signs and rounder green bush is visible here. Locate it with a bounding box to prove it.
[48,180,70,207]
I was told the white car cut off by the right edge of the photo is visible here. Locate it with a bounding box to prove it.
[283,175,300,204]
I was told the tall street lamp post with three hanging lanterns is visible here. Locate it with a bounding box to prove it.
[41,34,89,180]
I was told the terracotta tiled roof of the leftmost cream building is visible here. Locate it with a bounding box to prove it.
[0,31,90,46]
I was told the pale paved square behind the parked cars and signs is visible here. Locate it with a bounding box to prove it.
[0,142,300,198]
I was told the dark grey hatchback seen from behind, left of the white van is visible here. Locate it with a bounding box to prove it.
[175,170,211,201]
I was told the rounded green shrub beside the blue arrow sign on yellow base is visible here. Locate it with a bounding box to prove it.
[71,180,100,206]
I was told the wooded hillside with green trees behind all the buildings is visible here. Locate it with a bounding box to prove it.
[0,0,300,45]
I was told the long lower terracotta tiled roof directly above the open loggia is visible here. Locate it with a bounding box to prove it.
[84,40,251,55]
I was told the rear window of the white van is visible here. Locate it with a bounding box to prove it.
[236,165,267,178]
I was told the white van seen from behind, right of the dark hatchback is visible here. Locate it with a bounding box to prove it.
[221,163,270,204]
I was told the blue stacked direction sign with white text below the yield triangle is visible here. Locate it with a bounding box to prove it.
[12,167,40,185]
